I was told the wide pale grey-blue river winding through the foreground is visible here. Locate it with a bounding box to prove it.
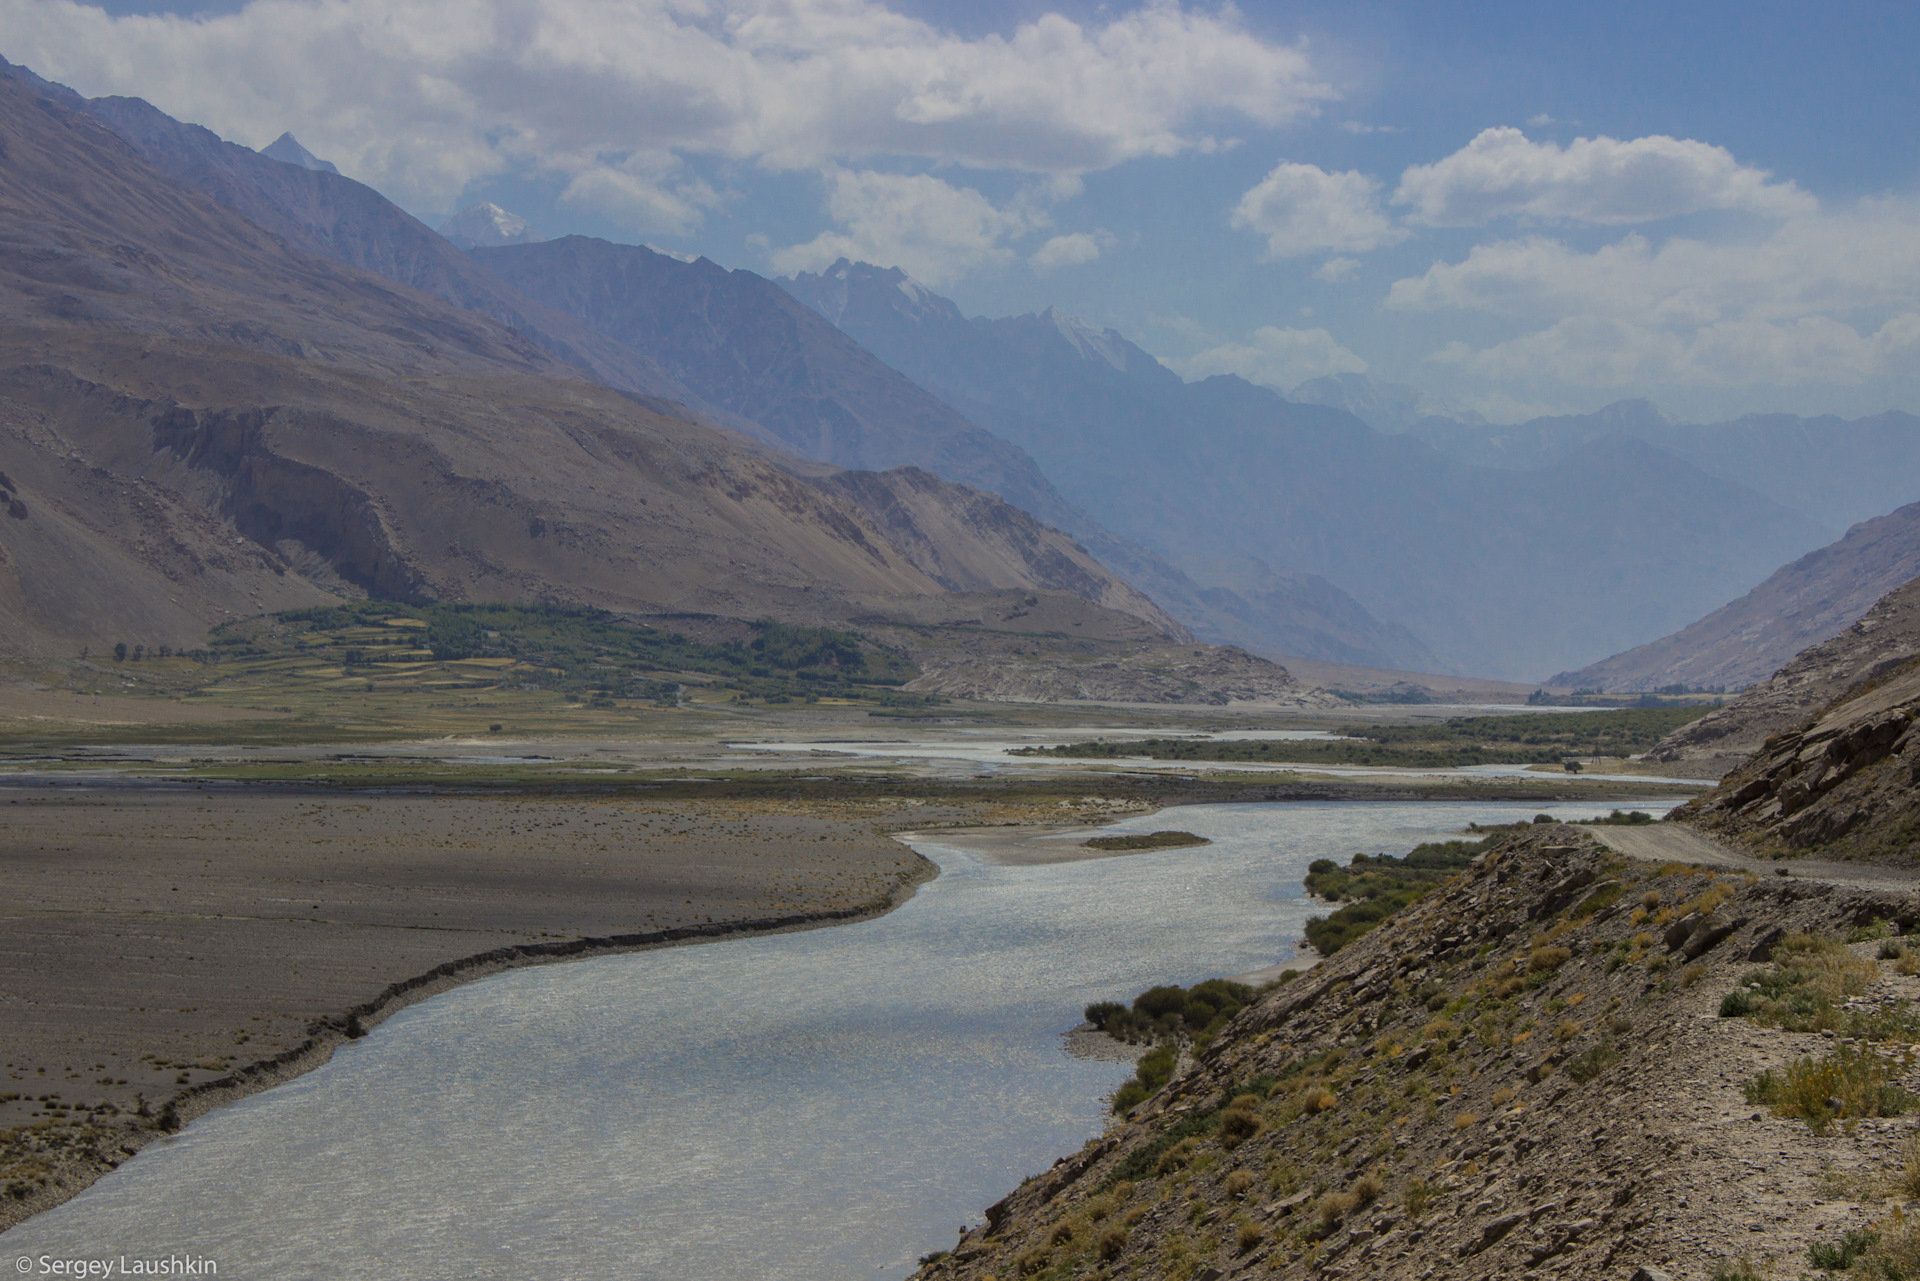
[0,803,1666,1281]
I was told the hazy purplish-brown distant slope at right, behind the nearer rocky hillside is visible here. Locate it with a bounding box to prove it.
[1548,503,1920,702]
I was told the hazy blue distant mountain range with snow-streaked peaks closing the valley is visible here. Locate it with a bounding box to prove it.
[789,261,1822,680]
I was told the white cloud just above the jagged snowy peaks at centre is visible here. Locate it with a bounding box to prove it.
[770,169,1044,286]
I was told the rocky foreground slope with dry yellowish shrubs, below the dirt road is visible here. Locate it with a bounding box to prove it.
[918,824,1920,1281]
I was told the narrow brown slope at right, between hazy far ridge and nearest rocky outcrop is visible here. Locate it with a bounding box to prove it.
[1651,580,1920,768]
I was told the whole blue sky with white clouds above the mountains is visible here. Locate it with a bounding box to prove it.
[0,0,1920,421]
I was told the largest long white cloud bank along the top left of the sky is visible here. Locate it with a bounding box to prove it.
[0,0,1332,217]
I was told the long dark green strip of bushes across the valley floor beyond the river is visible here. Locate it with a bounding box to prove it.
[1016,707,1713,768]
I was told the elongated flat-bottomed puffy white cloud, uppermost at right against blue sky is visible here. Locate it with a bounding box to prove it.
[1394,129,1818,227]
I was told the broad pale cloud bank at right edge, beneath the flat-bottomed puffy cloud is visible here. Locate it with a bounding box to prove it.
[1386,202,1920,386]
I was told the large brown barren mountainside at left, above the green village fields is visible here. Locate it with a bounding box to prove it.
[0,79,967,647]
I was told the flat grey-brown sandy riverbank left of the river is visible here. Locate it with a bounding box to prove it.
[0,786,937,1227]
